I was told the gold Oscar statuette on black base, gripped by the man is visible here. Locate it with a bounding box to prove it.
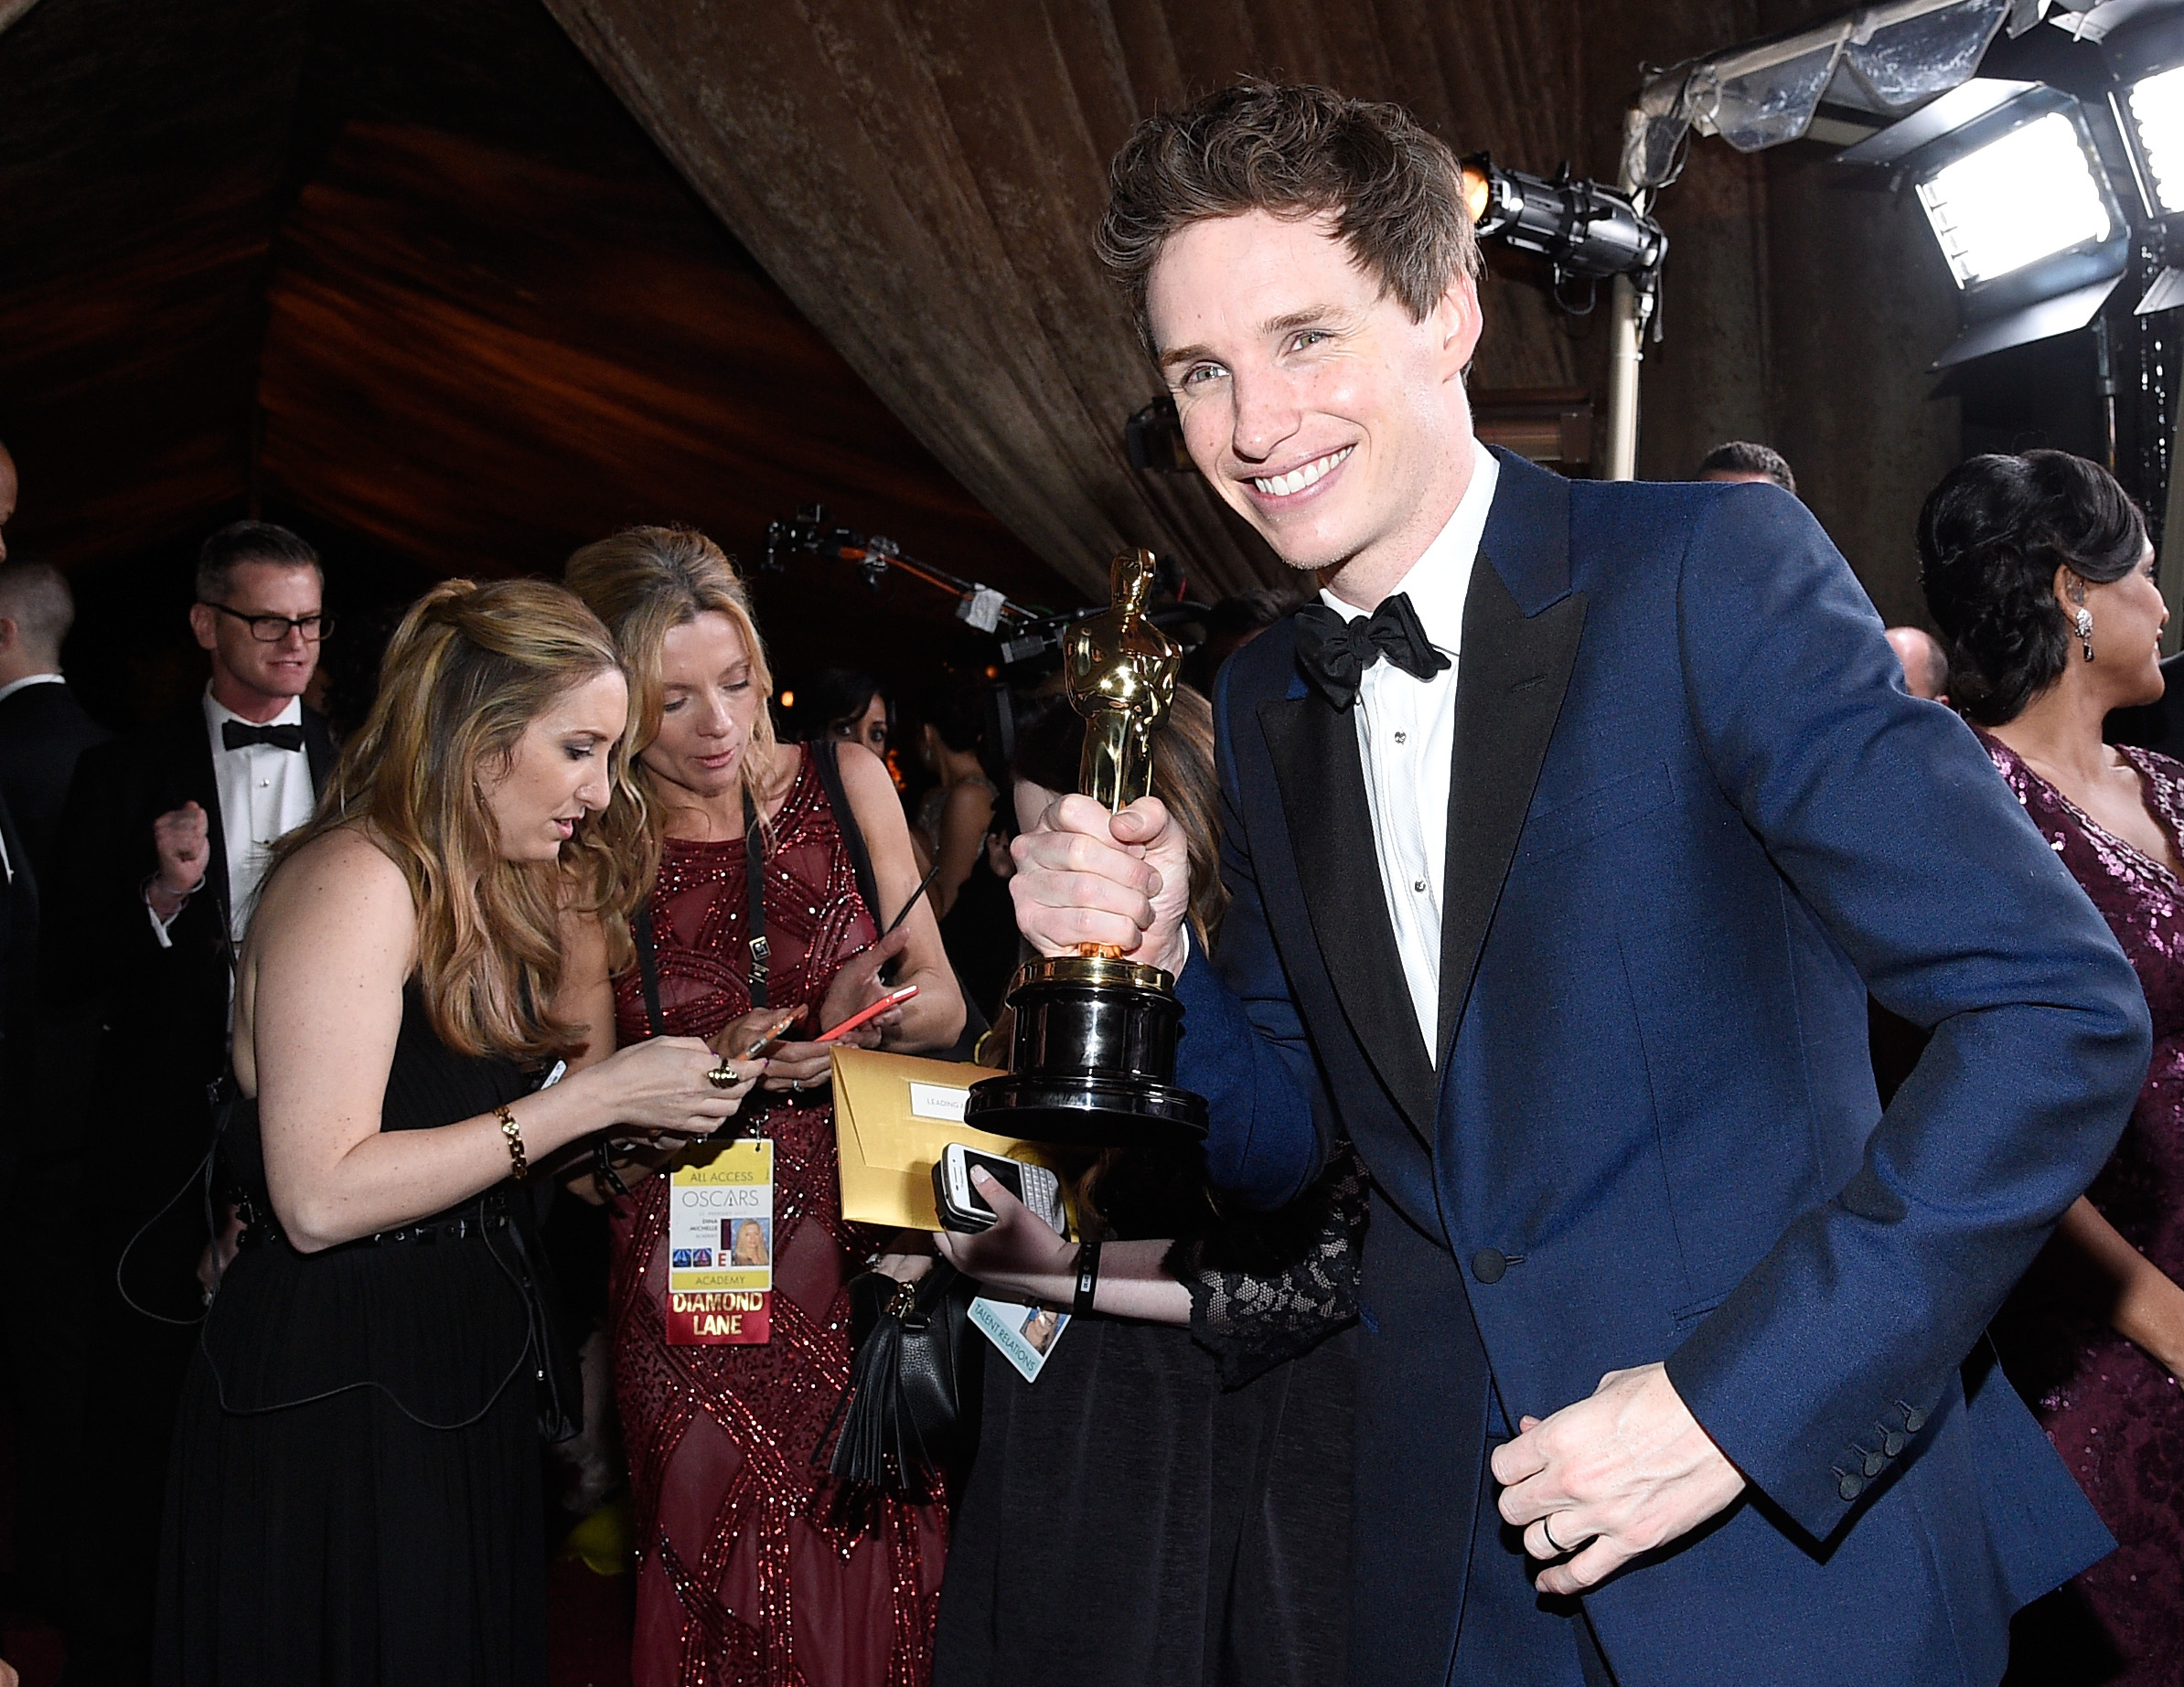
[963,550,1205,1146]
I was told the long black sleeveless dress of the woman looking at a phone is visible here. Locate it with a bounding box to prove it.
[153,982,574,1687]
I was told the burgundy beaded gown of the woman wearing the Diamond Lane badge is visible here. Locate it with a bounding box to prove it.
[612,751,946,1687]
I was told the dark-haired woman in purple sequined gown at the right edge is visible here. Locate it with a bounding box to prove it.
[1920,452,2184,1687]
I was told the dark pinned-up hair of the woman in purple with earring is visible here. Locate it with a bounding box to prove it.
[1918,452,2147,727]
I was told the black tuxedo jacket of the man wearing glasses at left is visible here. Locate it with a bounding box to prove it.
[39,699,334,1094]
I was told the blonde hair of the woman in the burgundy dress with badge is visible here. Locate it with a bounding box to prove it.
[562,529,777,891]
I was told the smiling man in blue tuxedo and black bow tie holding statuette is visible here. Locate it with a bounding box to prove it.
[1013,83,2149,1687]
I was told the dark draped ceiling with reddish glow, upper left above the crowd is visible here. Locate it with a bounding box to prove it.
[0,0,1079,724]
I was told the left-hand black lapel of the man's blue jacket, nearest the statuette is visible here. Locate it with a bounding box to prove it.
[1258,692,1437,1146]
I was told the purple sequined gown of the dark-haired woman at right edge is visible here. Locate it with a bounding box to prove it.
[1981,733,2184,1687]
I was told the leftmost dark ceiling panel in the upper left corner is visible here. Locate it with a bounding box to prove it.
[0,0,304,568]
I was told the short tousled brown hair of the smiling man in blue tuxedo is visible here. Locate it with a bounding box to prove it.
[1098,79,1481,358]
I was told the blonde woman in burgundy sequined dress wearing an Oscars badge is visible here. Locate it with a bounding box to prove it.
[568,529,963,1687]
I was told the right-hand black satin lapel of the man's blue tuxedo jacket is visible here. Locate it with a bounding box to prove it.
[1440,551,1586,1072]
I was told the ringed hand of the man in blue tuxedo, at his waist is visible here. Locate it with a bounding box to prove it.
[1492,1364,1745,1593]
